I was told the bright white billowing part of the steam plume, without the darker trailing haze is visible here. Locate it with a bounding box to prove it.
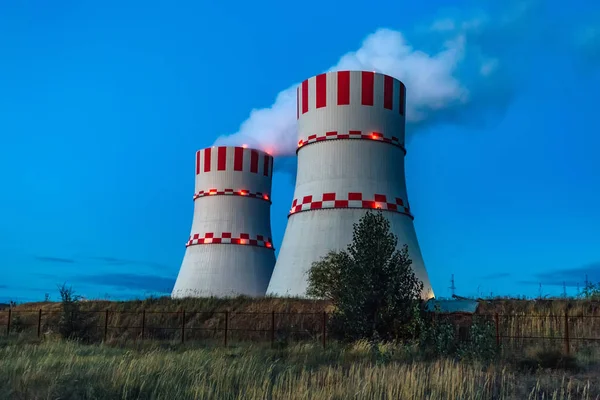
[216,29,469,156]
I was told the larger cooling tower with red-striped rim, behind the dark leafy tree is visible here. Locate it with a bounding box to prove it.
[267,71,433,298]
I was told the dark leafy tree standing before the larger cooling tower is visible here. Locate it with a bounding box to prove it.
[307,211,423,340]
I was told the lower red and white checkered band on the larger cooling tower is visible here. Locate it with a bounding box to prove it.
[289,192,413,218]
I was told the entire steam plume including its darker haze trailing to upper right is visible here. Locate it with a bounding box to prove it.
[215,1,597,159]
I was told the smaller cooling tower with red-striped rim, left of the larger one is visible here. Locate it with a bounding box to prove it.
[172,147,275,297]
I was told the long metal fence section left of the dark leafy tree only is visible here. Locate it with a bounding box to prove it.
[0,309,328,346]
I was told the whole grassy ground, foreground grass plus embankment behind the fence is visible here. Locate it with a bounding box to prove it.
[0,298,600,400]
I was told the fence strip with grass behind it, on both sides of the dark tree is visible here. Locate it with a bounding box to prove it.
[0,309,600,353]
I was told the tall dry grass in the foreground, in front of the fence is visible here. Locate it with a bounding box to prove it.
[0,342,600,400]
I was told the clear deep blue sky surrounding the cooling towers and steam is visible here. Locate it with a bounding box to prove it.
[0,0,600,301]
